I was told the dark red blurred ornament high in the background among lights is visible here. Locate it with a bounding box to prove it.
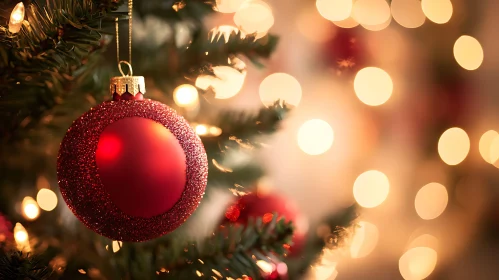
[324,28,367,74]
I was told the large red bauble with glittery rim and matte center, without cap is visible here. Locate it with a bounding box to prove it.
[57,99,208,242]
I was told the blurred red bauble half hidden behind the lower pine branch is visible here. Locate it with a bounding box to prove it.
[225,193,305,255]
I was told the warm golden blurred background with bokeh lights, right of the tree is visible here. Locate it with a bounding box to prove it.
[208,0,499,279]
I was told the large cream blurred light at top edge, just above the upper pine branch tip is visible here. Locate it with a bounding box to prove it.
[234,0,274,38]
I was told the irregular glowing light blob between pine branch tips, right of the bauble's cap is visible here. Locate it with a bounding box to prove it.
[196,66,246,99]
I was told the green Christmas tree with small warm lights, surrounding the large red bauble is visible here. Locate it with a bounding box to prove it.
[0,0,356,279]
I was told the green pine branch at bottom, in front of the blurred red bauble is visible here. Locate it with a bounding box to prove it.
[157,215,293,279]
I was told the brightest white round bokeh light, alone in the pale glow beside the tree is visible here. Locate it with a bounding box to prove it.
[298,119,334,155]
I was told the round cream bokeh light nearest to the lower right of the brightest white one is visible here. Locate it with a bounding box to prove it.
[353,170,390,208]
